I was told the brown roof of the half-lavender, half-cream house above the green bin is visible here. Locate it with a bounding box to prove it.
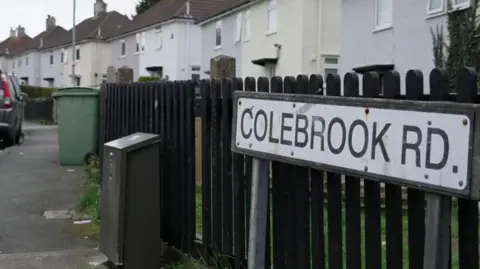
[43,11,132,49]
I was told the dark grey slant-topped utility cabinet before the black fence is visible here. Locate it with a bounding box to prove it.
[100,133,162,269]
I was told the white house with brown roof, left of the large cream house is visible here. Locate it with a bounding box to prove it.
[109,0,224,80]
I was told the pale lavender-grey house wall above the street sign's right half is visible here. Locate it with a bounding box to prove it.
[340,0,471,92]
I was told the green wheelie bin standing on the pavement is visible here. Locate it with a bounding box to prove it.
[52,87,100,165]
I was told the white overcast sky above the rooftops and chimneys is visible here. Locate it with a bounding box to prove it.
[0,0,137,40]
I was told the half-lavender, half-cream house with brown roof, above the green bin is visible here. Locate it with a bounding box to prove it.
[40,0,131,87]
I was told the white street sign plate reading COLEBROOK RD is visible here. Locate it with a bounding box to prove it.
[234,97,471,191]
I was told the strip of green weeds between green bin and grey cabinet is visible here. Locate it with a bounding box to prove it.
[76,160,100,238]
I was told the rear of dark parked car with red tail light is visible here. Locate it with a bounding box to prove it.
[0,69,28,147]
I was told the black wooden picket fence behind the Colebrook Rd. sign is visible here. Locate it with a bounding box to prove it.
[101,68,480,269]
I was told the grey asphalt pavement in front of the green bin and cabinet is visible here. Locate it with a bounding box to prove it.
[0,123,105,269]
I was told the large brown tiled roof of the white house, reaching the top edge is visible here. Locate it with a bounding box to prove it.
[116,0,229,37]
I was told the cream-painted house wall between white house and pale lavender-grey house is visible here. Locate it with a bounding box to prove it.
[240,0,343,77]
